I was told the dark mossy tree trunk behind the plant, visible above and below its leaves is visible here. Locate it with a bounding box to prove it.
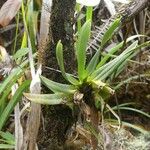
[39,0,75,150]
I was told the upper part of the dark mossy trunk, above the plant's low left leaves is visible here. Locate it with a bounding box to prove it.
[40,0,75,73]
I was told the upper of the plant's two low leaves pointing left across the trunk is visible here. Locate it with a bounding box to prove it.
[40,76,76,94]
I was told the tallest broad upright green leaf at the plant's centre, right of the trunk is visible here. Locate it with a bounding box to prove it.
[76,20,91,81]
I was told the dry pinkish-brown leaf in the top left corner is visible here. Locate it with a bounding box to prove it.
[0,0,22,27]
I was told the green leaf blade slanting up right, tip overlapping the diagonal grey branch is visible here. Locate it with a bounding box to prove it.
[101,18,121,47]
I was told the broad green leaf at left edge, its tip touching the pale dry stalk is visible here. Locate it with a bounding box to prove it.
[0,80,30,130]
